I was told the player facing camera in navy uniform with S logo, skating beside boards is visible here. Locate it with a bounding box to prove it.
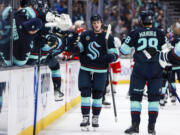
[68,15,118,130]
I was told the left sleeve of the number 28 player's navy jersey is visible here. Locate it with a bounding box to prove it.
[120,31,135,55]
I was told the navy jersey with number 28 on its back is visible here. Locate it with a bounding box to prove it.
[120,27,167,62]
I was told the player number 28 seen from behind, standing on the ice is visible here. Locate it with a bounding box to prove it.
[120,11,167,135]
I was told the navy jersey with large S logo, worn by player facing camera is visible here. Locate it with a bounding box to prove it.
[78,31,118,72]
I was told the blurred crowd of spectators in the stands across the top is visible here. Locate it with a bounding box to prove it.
[52,0,165,39]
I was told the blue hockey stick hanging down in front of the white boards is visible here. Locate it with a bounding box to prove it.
[33,47,41,135]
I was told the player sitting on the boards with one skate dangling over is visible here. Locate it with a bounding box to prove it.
[27,28,64,101]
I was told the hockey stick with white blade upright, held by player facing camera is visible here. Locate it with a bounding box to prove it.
[105,24,117,122]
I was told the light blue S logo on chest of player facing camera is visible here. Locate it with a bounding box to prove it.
[87,42,101,60]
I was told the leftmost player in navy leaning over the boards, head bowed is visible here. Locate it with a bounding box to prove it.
[1,4,42,66]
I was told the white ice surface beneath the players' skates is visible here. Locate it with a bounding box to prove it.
[38,84,180,135]
